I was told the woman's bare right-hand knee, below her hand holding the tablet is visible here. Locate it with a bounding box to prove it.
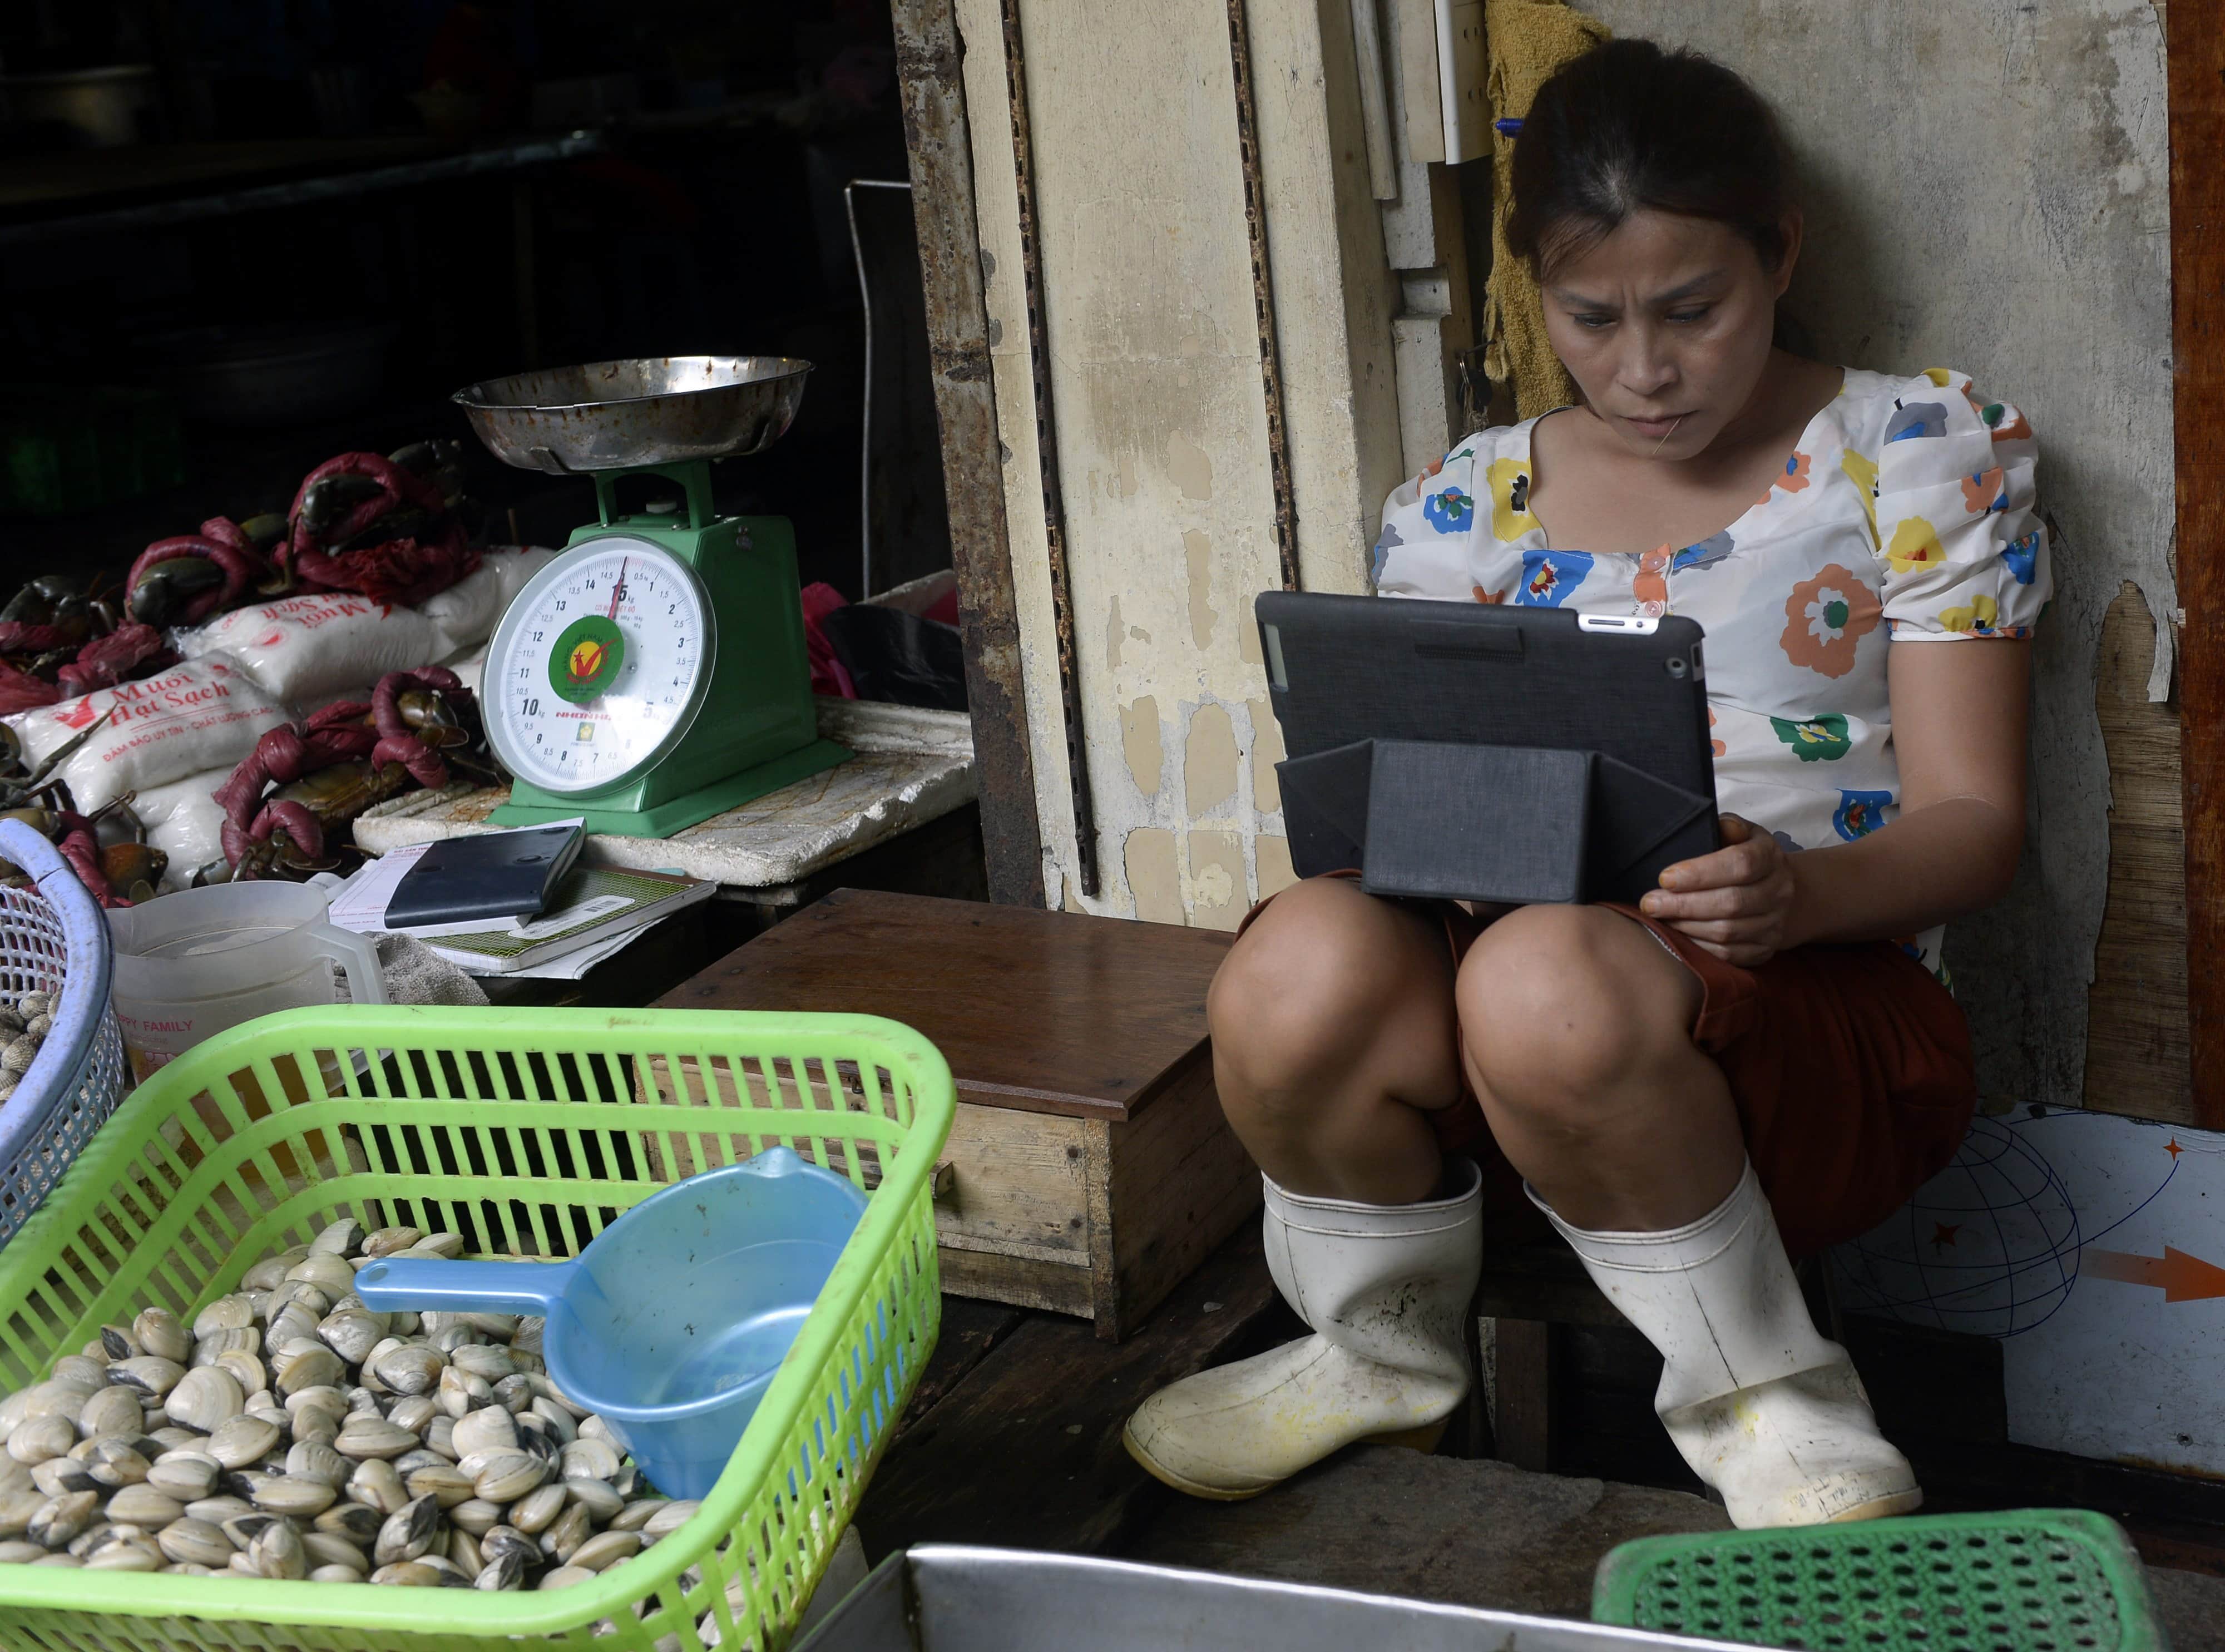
[1455,906,1698,1122]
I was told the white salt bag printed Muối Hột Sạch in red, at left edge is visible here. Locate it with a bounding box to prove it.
[7,655,287,815]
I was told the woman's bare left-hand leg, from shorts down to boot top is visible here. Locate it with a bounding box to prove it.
[1206,877,1460,1204]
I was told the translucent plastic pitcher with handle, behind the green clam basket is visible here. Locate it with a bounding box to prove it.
[109,882,387,1082]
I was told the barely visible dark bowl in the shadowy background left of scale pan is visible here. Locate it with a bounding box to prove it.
[147,320,398,426]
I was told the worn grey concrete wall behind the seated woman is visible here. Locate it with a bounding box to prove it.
[1586,0,2178,1113]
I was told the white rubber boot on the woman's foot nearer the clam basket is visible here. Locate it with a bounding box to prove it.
[1121,1160,1484,1503]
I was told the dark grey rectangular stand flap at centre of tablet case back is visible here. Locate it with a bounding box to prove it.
[1359,739,1593,904]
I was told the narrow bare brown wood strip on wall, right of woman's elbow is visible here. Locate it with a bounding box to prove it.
[2085,581,2194,1124]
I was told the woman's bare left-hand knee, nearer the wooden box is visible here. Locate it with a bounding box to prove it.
[1206,879,1451,1102]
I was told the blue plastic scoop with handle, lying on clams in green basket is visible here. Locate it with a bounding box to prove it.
[356,1146,866,1498]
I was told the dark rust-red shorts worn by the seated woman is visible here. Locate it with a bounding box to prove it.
[1244,882,1978,1256]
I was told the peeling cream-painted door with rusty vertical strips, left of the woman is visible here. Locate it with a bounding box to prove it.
[955,0,1468,928]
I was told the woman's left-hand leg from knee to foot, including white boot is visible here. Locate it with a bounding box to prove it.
[1121,879,1484,1498]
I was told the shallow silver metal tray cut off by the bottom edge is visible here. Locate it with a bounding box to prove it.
[792,1543,1762,1652]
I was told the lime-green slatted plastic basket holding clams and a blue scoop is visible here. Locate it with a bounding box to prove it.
[0,1006,957,1652]
